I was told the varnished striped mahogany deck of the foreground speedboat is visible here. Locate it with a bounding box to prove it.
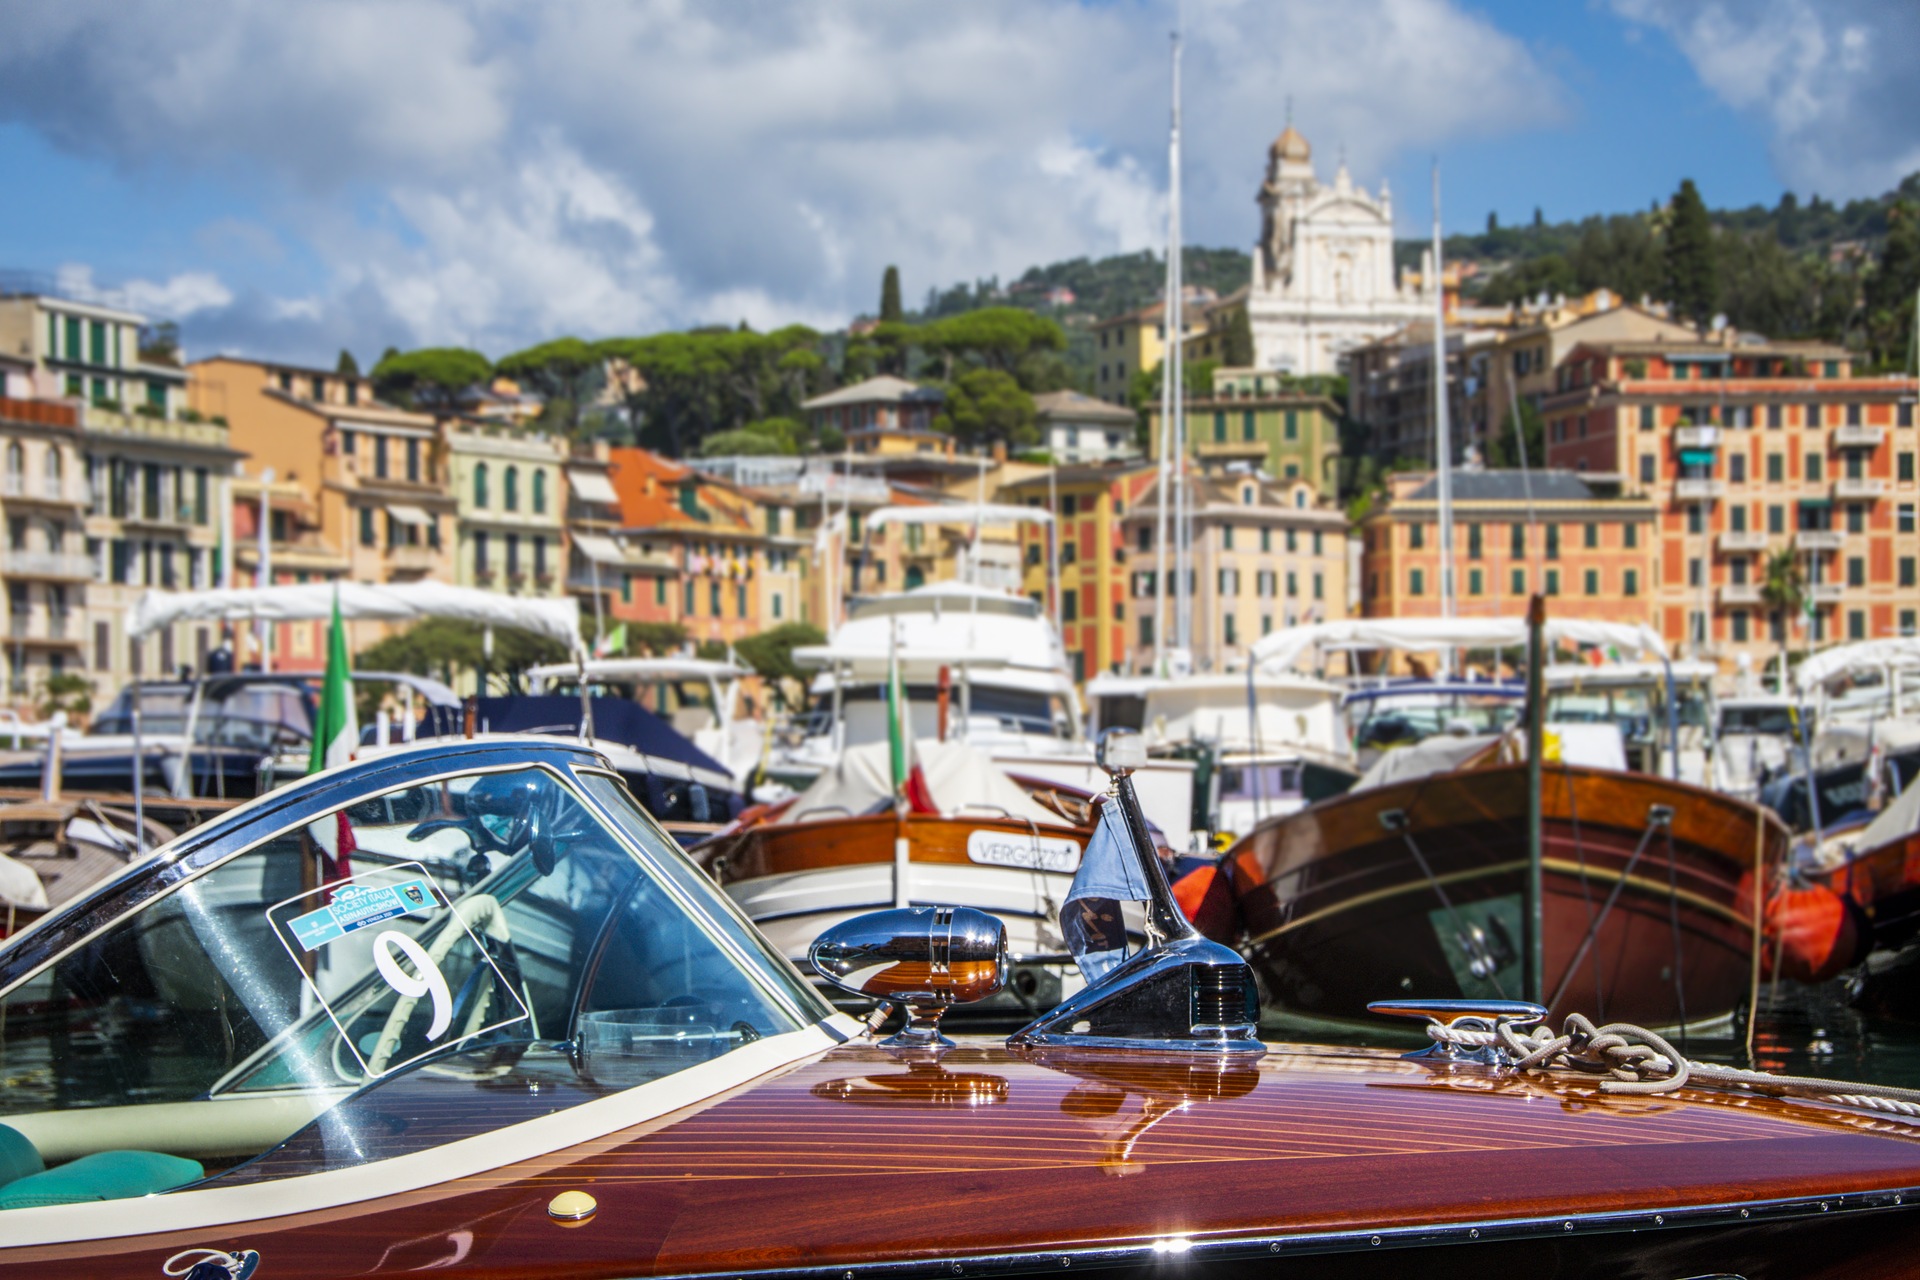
[0,1040,1920,1280]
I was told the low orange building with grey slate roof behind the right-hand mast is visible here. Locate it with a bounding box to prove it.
[1357,470,1659,622]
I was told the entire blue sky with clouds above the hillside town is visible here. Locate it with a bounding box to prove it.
[0,0,1920,365]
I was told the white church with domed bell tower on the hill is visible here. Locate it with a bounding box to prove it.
[1246,125,1432,374]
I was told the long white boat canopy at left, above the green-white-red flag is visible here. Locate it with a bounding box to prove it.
[127,580,584,652]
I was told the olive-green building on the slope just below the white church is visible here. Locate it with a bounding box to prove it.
[1146,368,1340,495]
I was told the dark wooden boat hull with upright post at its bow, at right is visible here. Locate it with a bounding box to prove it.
[1225,762,1788,1027]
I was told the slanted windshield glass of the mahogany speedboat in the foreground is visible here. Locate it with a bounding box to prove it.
[0,768,828,1190]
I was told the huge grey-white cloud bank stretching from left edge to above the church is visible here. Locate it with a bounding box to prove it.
[0,0,1561,359]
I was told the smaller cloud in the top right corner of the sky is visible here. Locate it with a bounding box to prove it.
[1611,0,1920,198]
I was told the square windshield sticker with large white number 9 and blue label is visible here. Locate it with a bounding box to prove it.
[267,850,530,1079]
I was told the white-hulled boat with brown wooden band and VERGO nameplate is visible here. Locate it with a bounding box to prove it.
[693,741,1091,1013]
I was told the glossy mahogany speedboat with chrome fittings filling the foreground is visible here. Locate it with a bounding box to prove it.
[0,741,1920,1280]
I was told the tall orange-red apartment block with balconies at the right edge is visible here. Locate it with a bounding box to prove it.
[1546,330,1920,668]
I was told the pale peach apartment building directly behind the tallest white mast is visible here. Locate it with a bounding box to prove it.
[1121,470,1348,672]
